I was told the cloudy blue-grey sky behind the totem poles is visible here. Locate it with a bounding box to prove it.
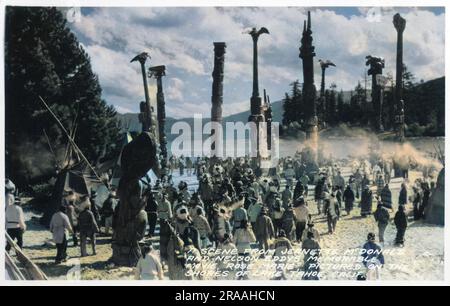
[70,7,445,118]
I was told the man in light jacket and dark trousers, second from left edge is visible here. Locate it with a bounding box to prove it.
[50,205,73,264]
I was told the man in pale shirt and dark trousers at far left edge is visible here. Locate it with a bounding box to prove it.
[5,198,27,252]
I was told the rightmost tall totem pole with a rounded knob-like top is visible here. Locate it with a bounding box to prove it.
[393,13,406,141]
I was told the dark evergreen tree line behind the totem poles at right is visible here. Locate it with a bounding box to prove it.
[281,66,445,137]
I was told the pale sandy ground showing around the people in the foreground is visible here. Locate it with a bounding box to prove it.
[17,169,444,280]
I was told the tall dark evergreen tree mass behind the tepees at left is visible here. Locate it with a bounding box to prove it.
[5,7,120,184]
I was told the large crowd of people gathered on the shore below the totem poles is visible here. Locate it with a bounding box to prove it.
[6,149,440,279]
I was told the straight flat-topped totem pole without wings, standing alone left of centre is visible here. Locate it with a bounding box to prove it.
[211,42,227,157]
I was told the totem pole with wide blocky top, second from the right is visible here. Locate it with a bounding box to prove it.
[366,55,384,132]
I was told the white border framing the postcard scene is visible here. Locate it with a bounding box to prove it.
[0,0,450,287]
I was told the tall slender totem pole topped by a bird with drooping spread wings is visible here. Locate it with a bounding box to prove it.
[248,27,269,166]
